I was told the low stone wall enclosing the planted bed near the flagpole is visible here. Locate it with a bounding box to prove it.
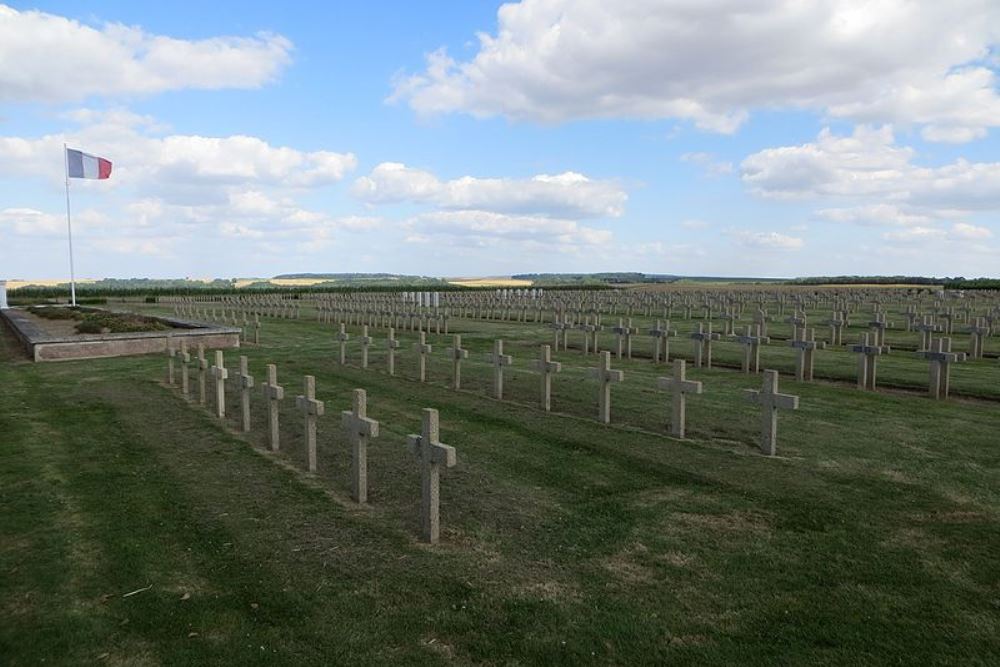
[0,309,240,361]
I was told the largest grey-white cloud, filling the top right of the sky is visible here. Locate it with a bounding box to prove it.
[390,0,1000,141]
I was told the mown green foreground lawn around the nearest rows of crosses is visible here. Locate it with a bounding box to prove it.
[0,311,1000,665]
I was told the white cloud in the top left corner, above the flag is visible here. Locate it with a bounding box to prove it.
[0,5,292,102]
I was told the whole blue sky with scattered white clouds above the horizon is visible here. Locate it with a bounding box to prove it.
[0,0,1000,279]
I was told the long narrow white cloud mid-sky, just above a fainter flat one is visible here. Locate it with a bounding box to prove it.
[352,162,628,218]
